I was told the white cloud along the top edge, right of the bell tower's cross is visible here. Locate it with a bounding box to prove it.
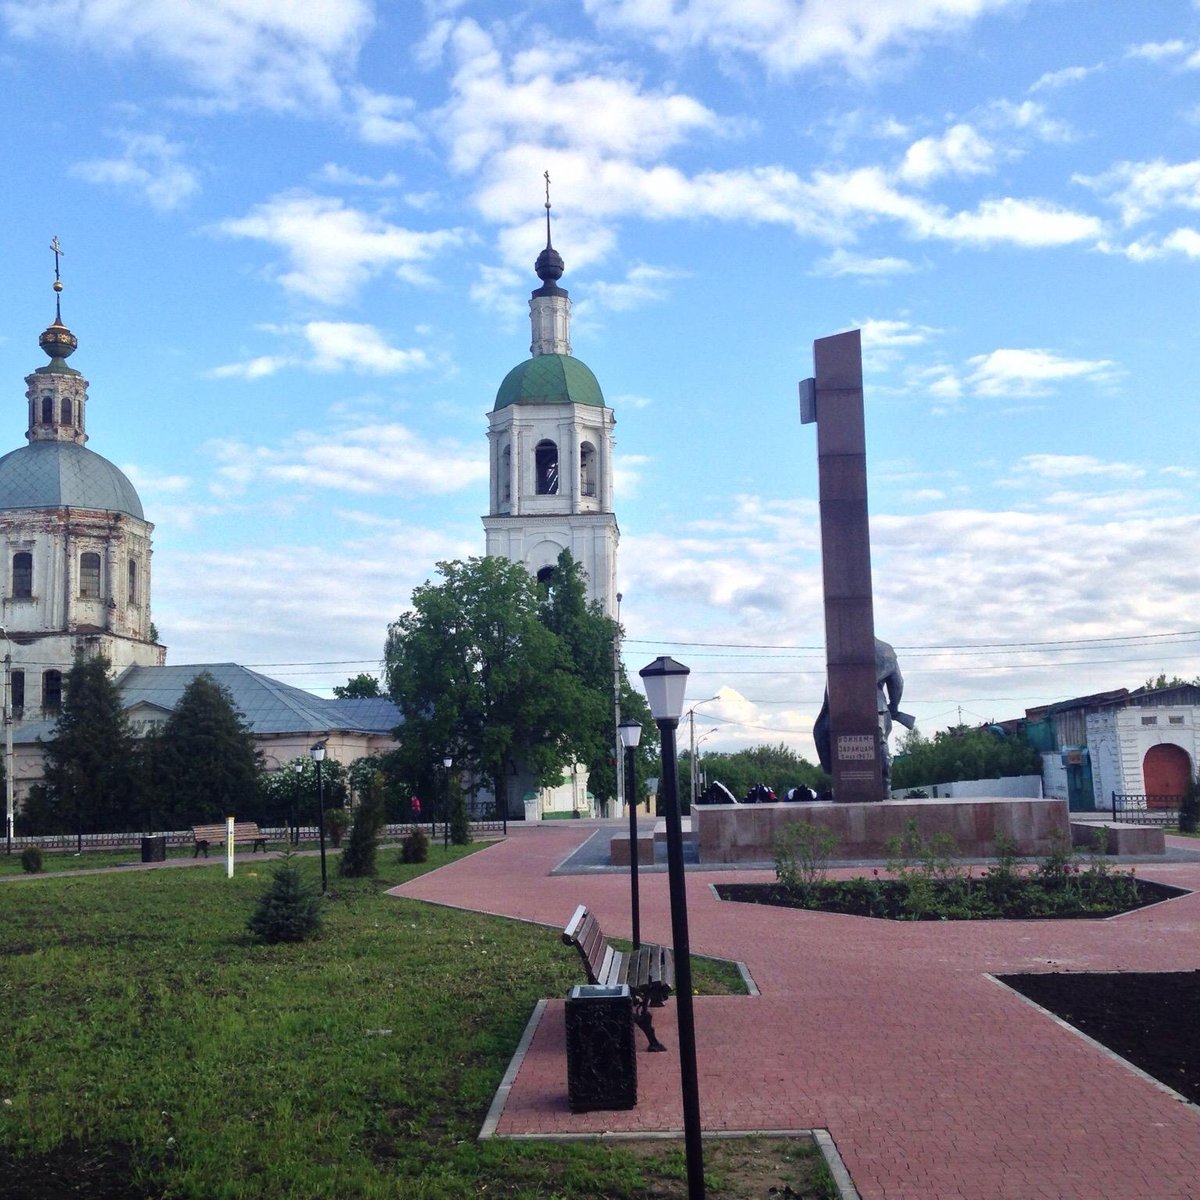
[584,0,1010,73]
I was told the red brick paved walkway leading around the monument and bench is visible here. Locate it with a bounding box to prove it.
[396,826,1200,1200]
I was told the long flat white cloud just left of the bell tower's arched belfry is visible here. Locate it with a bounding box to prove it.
[206,422,487,496]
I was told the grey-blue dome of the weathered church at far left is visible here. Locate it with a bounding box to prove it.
[0,442,145,521]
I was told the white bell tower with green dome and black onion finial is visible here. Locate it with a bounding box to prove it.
[484,173,620,617]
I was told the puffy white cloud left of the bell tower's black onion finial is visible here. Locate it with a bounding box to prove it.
[217,192,463,304]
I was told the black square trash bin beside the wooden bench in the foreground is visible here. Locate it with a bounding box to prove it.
[566,984,637,1112]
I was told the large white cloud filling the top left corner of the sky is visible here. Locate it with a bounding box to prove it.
[2,0,373,110]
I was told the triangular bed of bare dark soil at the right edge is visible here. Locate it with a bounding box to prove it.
[998,971,1200,1104]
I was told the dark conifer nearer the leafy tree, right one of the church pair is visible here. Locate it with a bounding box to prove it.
[162,671,259,828]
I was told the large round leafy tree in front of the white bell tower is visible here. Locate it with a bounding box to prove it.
[384,558,588,820]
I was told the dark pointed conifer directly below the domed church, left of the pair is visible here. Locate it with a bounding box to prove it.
[23,656,142,834]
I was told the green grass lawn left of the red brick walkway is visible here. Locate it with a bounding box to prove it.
[0,847,825,1200]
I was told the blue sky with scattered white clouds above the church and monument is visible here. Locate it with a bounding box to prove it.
[0,0,1200,754]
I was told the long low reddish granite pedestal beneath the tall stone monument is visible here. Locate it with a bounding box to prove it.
[692,797,1070,864]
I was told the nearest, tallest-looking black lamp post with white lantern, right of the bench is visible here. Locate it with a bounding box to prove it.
[638,656,704,1200]
